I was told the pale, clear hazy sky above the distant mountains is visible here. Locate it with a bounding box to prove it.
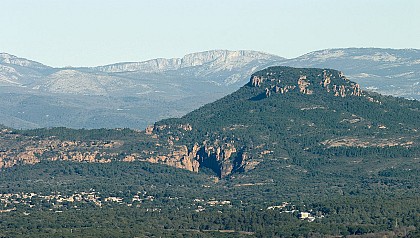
[0,0,420,66]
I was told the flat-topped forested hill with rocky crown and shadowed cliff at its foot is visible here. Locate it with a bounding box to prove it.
[153,67,420,177]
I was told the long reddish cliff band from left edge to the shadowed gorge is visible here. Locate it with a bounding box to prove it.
[0,124,252,177]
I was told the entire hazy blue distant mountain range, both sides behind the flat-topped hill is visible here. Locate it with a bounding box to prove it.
[0,48,420,129]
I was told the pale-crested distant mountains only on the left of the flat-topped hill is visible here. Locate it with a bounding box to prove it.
[0,50,285,129]
